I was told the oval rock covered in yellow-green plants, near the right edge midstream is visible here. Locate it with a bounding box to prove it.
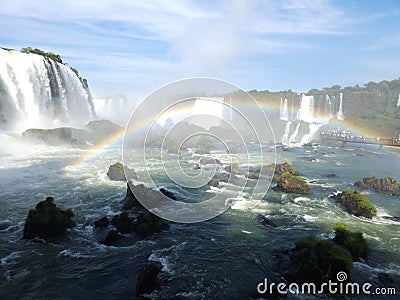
[331,190,376,219]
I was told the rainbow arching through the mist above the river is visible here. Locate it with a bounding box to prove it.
[68,101,382,172]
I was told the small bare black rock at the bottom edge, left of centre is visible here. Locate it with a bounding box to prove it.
[136,263,162,296]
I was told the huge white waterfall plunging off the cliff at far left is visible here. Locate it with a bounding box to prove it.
[0,49,95,130]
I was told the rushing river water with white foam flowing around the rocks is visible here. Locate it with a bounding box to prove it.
[0,139,400,299]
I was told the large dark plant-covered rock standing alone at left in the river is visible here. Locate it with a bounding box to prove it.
[23,197,75,239]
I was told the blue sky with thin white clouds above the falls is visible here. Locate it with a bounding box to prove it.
[0,0,400,97]
